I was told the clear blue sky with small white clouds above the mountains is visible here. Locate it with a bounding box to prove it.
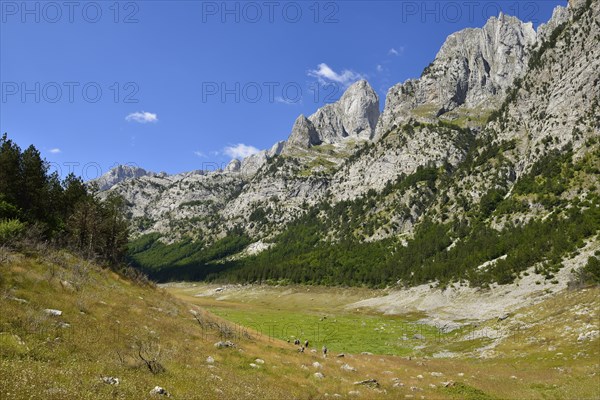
[0,0,566,179]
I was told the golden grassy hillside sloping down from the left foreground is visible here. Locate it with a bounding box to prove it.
[0,248,342,399]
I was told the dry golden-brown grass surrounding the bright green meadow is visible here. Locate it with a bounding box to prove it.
[0,252,600,399]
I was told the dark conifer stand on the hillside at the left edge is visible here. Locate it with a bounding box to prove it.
[0,133,129,266]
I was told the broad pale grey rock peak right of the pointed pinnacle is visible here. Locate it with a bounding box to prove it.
[376,14,537,136]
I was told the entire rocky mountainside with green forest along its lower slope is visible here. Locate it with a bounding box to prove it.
[113,1,600,285]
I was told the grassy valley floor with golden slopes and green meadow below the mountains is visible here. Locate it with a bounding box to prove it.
[0,248,600,399]
